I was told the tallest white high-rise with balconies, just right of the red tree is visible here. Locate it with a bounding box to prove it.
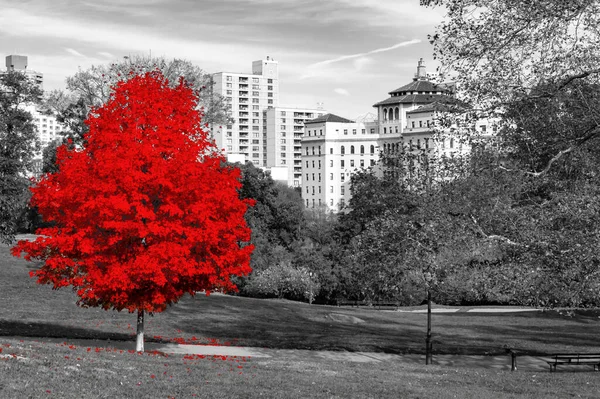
[212,57,279,166]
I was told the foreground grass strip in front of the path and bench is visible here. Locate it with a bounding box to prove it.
[0,337,600,399]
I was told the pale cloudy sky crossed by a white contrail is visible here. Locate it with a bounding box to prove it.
[0,0,444,119]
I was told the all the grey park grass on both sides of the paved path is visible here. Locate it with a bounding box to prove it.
[0,247,600,398]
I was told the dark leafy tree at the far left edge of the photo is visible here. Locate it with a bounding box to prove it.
[0,71,41,243]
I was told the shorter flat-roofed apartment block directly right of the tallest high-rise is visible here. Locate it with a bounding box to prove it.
[263,107,325,187]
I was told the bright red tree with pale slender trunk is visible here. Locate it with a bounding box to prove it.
[12,72,252,351]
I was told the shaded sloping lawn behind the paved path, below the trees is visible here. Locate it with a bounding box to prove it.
[0,247,600,354]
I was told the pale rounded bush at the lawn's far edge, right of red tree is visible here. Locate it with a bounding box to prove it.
[243,263,320,300]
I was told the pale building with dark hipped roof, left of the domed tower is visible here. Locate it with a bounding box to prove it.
[301,114,379,212]
